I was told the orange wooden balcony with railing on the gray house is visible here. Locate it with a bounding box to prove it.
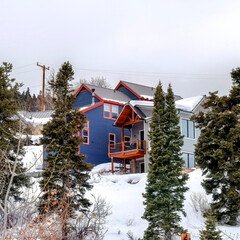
[108,140,146,159]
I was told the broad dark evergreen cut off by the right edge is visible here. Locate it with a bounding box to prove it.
[192,68,240,225]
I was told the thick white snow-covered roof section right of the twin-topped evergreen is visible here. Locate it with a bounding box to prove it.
[175,96,204,112]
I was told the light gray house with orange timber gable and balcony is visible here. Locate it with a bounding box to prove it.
[109,96,205,173]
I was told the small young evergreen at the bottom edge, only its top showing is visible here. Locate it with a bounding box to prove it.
[200,211,222,240]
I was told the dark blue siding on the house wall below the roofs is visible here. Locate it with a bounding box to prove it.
[80,105,130,165]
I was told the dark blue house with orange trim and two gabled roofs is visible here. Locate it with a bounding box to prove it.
[73,81,181,165]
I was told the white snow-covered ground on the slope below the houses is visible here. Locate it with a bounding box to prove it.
[21,143,240,240]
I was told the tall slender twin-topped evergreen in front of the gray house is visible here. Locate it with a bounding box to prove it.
[143,83,188,240]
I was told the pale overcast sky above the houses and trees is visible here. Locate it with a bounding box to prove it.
[0,0,240,97]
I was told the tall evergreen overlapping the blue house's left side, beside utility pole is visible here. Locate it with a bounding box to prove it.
[39,62,92,240]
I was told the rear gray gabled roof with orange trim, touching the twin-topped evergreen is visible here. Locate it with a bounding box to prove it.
[115,81,182,101]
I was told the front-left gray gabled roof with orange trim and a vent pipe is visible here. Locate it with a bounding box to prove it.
[75,83,131,104]
